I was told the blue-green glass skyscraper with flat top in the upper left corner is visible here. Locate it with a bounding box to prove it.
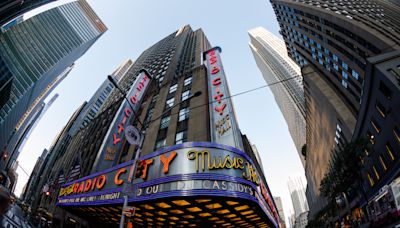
[0,0,106,176]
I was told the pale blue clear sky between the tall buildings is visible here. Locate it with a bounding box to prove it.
[16,0,303,224]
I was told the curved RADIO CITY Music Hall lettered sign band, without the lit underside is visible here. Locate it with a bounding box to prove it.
[58,142,278,226]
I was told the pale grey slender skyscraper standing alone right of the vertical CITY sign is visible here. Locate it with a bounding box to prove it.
[249,27,306,166]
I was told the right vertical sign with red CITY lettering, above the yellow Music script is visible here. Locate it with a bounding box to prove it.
[204,47,243,150]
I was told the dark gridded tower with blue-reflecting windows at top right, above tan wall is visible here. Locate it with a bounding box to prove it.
[271,0,400,114]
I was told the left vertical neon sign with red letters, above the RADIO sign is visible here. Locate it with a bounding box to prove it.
[93,70,151,171]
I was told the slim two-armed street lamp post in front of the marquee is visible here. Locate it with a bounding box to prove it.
[108,75,202,228]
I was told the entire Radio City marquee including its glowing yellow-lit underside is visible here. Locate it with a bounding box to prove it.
[58,142,279,227]
